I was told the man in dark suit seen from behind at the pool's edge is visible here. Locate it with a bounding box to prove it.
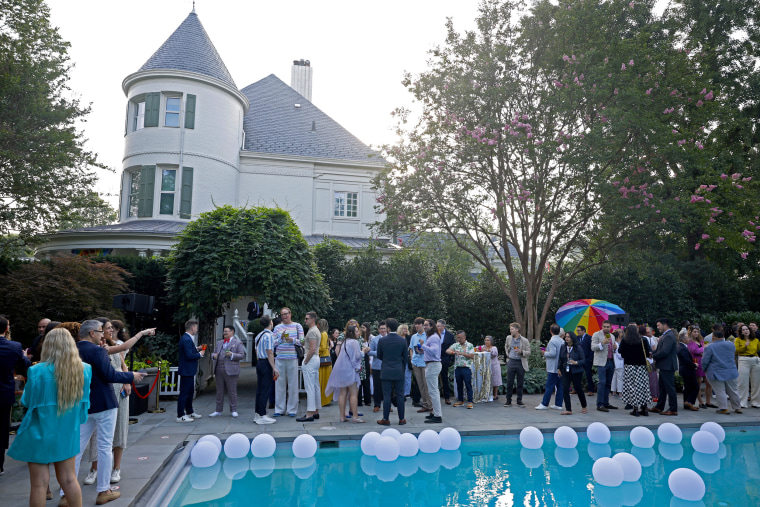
[375,319,407,426]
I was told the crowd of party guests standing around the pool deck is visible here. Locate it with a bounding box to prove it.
[0,308,760,506]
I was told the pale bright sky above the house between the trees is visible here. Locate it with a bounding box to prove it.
[48,0,479,205]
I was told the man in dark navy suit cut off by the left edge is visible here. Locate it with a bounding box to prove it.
[0,316,32,475]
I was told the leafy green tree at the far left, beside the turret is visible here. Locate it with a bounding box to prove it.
[0,0,105,254]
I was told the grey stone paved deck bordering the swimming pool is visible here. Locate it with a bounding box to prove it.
[0,366,760,507]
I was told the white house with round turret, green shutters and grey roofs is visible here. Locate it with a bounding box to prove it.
[39,12,383,256]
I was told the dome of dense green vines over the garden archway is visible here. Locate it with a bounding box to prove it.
[167,206,330,323]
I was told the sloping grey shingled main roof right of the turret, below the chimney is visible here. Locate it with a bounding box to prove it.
[241,74,382,161]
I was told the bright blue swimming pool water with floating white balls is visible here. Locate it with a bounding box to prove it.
[170,428,760,507]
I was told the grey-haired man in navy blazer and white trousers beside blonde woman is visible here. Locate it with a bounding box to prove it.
[70,320,145,505]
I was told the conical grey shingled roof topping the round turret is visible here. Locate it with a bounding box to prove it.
[140,12,237,88]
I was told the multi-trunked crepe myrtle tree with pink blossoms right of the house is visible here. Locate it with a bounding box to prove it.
[375,0,748,339]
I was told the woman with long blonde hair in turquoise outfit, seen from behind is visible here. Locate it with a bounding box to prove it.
[8,328,92,507]
